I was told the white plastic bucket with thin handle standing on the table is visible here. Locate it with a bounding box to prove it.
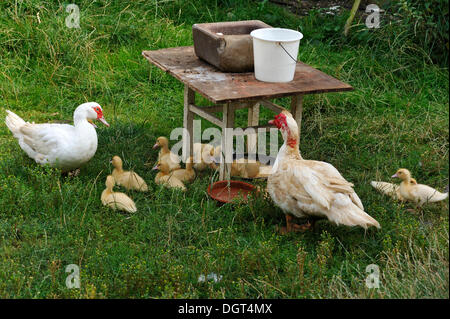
[250,28,303,82]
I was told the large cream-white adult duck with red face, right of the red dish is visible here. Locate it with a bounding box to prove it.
[267,111,380,232]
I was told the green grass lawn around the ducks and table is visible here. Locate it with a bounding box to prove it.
[0,0,449,298]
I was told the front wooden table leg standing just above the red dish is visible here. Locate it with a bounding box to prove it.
[219,103,234,180]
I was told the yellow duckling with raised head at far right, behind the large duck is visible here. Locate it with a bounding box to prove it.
[392,168,448,207]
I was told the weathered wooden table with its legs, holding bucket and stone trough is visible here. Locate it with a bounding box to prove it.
[142,46,353,180]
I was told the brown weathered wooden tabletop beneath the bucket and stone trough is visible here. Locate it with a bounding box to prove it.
[142,46,353,103]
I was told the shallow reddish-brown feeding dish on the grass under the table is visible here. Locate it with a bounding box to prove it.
[208,181,256,203]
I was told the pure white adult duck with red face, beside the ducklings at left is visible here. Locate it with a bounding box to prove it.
[5,102,109,172]
